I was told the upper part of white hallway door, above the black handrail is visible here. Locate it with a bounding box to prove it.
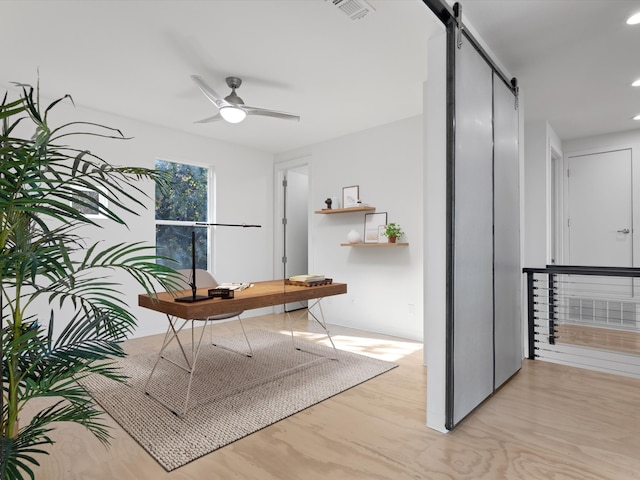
[565,149,633,267]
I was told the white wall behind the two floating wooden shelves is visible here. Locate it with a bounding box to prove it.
[276,116,423,340]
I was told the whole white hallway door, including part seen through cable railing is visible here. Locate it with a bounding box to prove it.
[557,149,635,330]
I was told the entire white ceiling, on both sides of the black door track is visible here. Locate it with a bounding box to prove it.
[0,0,640,153]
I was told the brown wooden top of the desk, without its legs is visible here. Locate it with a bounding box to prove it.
[138,280,347,319]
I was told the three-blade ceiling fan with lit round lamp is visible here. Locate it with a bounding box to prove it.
[191,75,300,123]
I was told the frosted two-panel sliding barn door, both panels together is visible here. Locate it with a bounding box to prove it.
[446,37,522,429]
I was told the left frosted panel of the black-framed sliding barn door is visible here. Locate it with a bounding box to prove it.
[450,37,493,424]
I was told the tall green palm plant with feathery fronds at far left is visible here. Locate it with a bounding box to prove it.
[0,85,182,479]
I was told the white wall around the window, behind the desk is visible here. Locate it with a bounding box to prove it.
[43,103,273,336]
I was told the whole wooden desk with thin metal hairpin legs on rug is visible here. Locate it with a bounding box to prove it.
[138,280,347,416]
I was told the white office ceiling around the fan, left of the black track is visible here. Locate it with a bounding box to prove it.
[0,0,439,152]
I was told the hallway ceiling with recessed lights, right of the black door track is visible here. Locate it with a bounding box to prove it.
[462,0,640,140]
